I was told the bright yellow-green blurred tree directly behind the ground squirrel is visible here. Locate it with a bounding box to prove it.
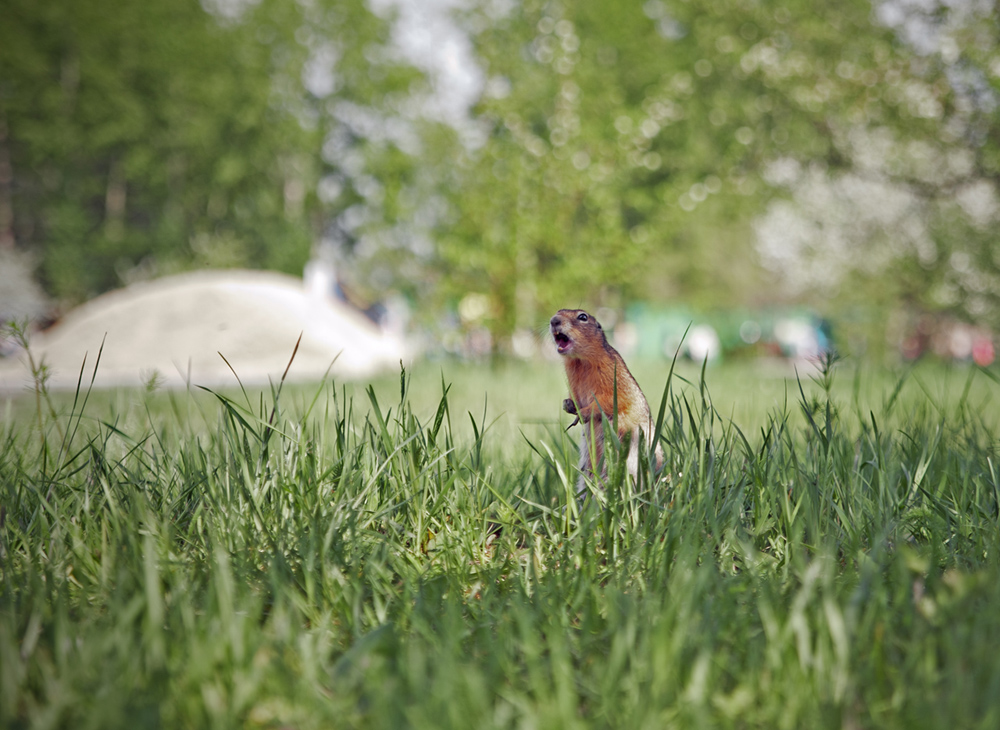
[424,0,920,344]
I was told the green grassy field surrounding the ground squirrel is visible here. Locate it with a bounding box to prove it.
[0,350,1000,729]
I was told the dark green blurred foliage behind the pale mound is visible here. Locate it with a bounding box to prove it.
[0,0,315,300]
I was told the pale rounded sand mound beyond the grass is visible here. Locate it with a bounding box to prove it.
[0,271,406,389]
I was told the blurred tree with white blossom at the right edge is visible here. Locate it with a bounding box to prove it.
[758,0,1000,349]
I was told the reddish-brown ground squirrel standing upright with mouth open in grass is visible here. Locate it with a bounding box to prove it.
[549,309,663,492]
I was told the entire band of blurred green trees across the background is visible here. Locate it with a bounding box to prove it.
[0,0,1000,350]
